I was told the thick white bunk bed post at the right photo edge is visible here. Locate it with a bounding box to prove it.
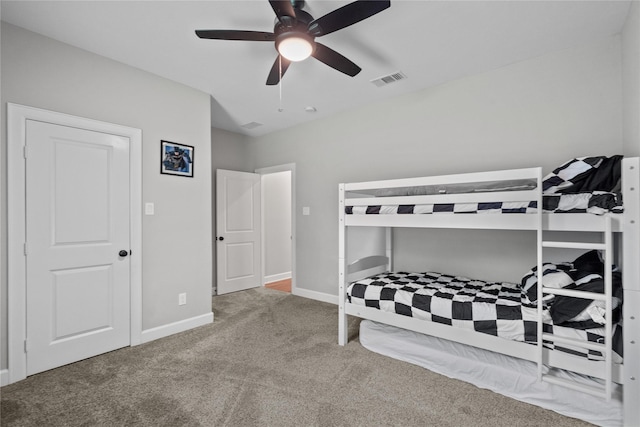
[622,157,640,426]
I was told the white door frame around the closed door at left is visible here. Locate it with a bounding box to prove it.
[7,103,142,384]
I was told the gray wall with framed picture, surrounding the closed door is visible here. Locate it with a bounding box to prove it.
[0,23,212,369]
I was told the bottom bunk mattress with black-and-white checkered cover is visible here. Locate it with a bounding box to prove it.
[347,272,622,363]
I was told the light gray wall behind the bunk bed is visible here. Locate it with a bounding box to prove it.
[251,37,623,295]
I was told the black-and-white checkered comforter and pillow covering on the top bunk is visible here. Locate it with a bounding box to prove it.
[345,156,623,215]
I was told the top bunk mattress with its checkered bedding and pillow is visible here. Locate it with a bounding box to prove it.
[345,156,623,215]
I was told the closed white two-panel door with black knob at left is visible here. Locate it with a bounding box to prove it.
[25,120,130,375]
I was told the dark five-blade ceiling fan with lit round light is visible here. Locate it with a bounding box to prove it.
[196,0,391,85]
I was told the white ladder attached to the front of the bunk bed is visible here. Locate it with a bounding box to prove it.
[537,215,613,402]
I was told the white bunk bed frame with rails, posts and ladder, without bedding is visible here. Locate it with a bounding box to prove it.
[338,158,640,426]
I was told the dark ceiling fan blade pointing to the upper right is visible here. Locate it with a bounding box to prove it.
[309,0,391,37]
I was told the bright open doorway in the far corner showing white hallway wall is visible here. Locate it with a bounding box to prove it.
[256,164,296,294]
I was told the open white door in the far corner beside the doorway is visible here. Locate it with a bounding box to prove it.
[216,169,262,295]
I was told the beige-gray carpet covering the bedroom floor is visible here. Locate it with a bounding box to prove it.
[0,288,586,427]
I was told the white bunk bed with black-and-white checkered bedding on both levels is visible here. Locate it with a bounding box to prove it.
[338,156,640,425]
